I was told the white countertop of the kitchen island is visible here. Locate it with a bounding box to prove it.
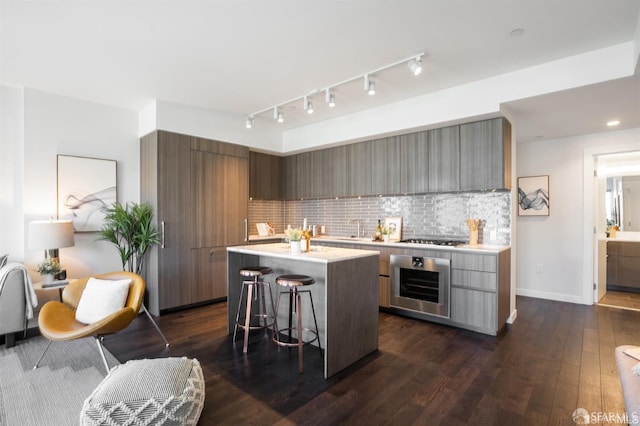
[227,240,380,263]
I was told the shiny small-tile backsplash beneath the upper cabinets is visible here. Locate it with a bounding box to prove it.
[249,192,511,245]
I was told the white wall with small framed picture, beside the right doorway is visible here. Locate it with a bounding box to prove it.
[514,129,640,304]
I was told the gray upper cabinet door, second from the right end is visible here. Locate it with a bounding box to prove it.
[428,126,460,192]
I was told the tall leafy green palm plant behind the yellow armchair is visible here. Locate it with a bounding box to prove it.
[99,203,160,275]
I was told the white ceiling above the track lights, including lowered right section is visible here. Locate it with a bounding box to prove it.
[0,0,640,140]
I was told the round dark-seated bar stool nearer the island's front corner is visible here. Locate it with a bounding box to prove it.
[273,275,322,373]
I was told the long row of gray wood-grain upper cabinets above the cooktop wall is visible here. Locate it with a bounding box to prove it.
[280,118,511,200]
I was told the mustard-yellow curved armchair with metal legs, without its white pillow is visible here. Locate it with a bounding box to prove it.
[33,271,145,372]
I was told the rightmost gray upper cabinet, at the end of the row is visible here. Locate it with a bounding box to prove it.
[460,118,511,191]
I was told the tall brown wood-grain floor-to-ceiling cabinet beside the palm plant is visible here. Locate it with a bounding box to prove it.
[140,131,249,315]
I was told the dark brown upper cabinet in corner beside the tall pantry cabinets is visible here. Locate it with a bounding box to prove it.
[249,151,284,200]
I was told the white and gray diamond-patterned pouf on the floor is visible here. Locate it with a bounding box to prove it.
[80,357,205,426]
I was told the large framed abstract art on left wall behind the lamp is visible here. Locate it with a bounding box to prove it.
[58,155,117,232]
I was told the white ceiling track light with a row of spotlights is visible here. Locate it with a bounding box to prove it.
[246,53,424,129]
